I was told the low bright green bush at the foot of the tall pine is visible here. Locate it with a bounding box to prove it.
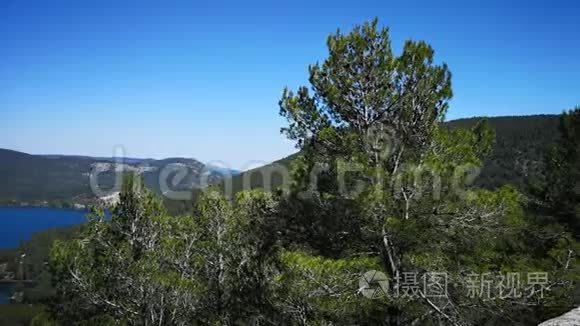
[274,251,386,325]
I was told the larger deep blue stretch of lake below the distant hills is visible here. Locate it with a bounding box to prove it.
[0,207,87,249]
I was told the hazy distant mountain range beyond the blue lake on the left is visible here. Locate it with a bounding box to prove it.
[0,149,225,205]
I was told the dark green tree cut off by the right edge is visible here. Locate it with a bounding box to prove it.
[527,108,580,315]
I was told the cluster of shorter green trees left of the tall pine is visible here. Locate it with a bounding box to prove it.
[50,176,276,325]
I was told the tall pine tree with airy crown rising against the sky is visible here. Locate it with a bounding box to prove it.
[280,20,572,325]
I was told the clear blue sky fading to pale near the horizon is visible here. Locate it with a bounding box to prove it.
[0,0,580,168]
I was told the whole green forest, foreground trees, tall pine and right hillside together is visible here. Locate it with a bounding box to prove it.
[0,20,580,325]
